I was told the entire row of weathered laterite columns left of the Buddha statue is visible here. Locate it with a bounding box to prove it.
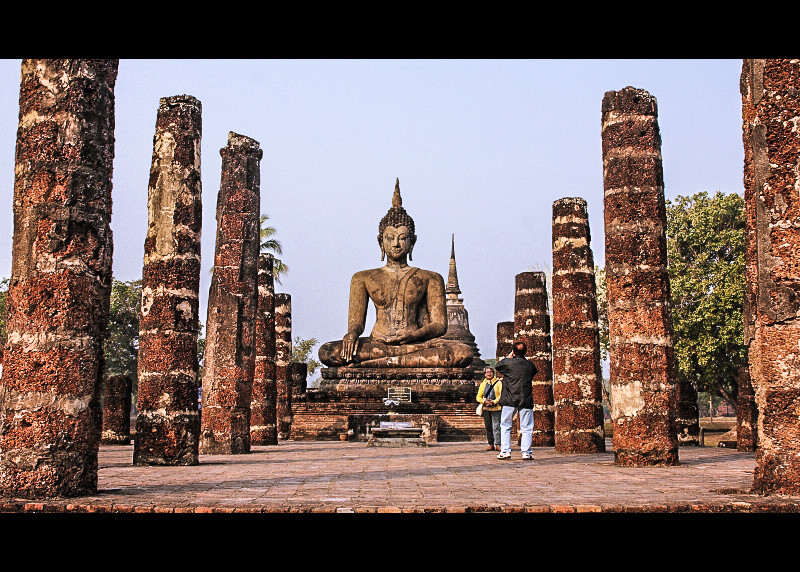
[0,60,303,498]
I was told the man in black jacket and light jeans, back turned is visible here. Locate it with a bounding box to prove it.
[495,341,537,461]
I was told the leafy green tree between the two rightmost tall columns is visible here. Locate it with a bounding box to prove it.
[666,191,747,406]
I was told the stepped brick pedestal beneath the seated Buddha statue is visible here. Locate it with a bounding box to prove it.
[290,367,486,443]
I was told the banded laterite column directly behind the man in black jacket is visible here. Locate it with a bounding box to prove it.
[514,272,555,447]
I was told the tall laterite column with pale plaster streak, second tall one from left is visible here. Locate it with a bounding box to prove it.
[133,95,203,465]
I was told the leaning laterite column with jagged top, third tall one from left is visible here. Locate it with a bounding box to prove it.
[200,133,263,454]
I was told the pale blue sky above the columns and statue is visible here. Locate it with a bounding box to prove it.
[0,59,743,376]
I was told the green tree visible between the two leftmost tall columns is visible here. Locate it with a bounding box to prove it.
[103,279,142,403]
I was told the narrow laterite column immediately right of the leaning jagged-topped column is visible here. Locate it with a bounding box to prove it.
[250,254,278,445]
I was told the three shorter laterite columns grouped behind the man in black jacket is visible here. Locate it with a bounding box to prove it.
[496,198,605,453]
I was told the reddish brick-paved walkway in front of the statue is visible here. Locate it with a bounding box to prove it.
[0,440,800,514]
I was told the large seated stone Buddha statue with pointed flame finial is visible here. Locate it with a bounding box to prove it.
[319,179,473,368]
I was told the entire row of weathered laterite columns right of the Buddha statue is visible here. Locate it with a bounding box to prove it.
[497,76,800,478]
